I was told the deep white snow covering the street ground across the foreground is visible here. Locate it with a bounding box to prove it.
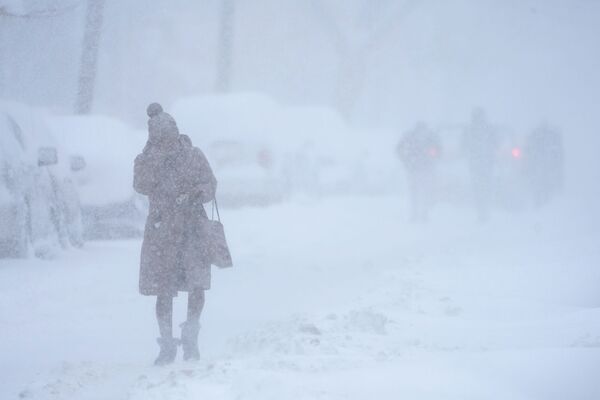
[0,197,600,400]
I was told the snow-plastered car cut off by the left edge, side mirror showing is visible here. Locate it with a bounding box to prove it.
[0,102,83,258]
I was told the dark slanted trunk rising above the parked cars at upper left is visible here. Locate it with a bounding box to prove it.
[75,0,105,114]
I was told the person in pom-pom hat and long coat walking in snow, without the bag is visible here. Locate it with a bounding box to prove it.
[133,103,217,365]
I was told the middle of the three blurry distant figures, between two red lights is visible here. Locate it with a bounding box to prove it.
[462,108,499,222]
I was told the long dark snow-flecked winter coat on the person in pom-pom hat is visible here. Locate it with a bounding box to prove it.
[133,135,217,296]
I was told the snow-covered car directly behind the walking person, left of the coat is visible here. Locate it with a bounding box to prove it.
[48,115,148,240]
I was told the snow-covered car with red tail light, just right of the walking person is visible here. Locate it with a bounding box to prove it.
[168,94,288,207]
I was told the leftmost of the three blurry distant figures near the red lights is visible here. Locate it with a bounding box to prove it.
[396,122,441,222]
